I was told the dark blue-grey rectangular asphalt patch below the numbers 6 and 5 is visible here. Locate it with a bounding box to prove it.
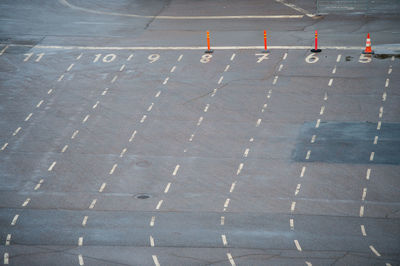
[292,121,400,165]
